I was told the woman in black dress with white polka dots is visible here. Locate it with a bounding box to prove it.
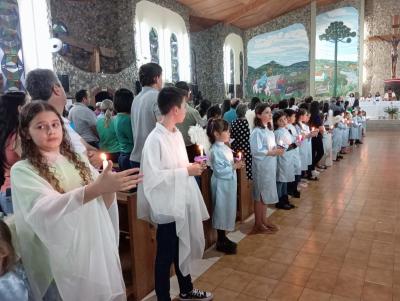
[231,103,251,180]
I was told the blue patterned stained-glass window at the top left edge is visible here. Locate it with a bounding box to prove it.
[0,0,25,93]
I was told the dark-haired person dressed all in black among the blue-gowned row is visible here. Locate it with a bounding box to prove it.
[309,101,326,172]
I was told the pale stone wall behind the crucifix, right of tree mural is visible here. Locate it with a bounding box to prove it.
[363,0,400,95]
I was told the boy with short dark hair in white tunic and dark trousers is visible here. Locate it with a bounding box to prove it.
[138,87,213,301]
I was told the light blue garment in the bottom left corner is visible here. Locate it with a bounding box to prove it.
[0,264,33,301]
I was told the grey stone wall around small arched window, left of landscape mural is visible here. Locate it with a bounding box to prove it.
[190,23,243,103]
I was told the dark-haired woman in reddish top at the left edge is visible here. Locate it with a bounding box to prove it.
[0,92,26,214]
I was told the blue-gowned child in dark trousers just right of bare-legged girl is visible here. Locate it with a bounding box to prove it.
[273,110,297,210]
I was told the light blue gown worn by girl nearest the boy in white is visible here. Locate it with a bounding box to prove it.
[210,142,237,231]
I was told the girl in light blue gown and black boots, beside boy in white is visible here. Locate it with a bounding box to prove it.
[207,119,244,254]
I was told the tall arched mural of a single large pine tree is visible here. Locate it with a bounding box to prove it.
[315,7,359,96]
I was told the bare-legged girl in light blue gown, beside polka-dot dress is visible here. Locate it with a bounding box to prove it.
[250,103,284,234]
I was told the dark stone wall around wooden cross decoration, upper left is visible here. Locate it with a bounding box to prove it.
[50,0,189,95]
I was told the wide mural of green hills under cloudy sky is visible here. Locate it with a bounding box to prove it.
[246,24,310,102]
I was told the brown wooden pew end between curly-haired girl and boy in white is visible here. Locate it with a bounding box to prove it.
[117,192,156,301]
